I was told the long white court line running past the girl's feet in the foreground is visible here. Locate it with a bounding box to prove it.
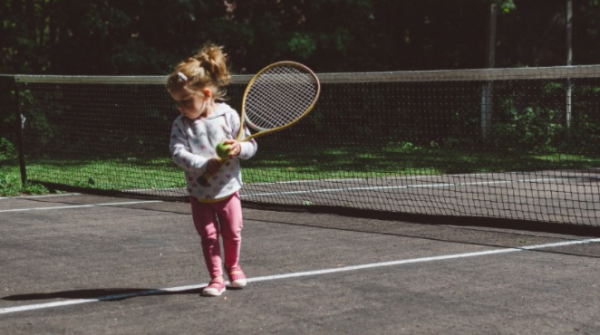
[0,238,600,315]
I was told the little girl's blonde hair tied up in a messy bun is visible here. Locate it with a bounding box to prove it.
[167,44,230,100]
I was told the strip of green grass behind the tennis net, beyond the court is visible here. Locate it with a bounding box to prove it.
[0,143,600,196]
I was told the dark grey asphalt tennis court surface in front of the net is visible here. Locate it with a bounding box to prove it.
[0,194,600,334]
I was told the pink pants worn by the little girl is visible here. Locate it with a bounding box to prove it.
[190,192,243,278]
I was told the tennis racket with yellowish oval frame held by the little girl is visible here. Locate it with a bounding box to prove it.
[198,61,321,186]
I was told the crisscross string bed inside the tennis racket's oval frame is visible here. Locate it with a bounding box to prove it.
[245,66,318,130]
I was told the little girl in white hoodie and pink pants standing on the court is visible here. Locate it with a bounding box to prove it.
[167,45,257,296]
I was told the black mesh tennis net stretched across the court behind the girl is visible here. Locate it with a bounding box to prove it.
[8,65,600,226]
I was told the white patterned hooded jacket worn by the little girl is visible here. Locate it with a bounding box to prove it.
[169,103,258,202]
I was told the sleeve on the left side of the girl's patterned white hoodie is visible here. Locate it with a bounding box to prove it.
[169,117,208,173]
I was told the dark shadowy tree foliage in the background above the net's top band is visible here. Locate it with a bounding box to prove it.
[0,0,600,75]
